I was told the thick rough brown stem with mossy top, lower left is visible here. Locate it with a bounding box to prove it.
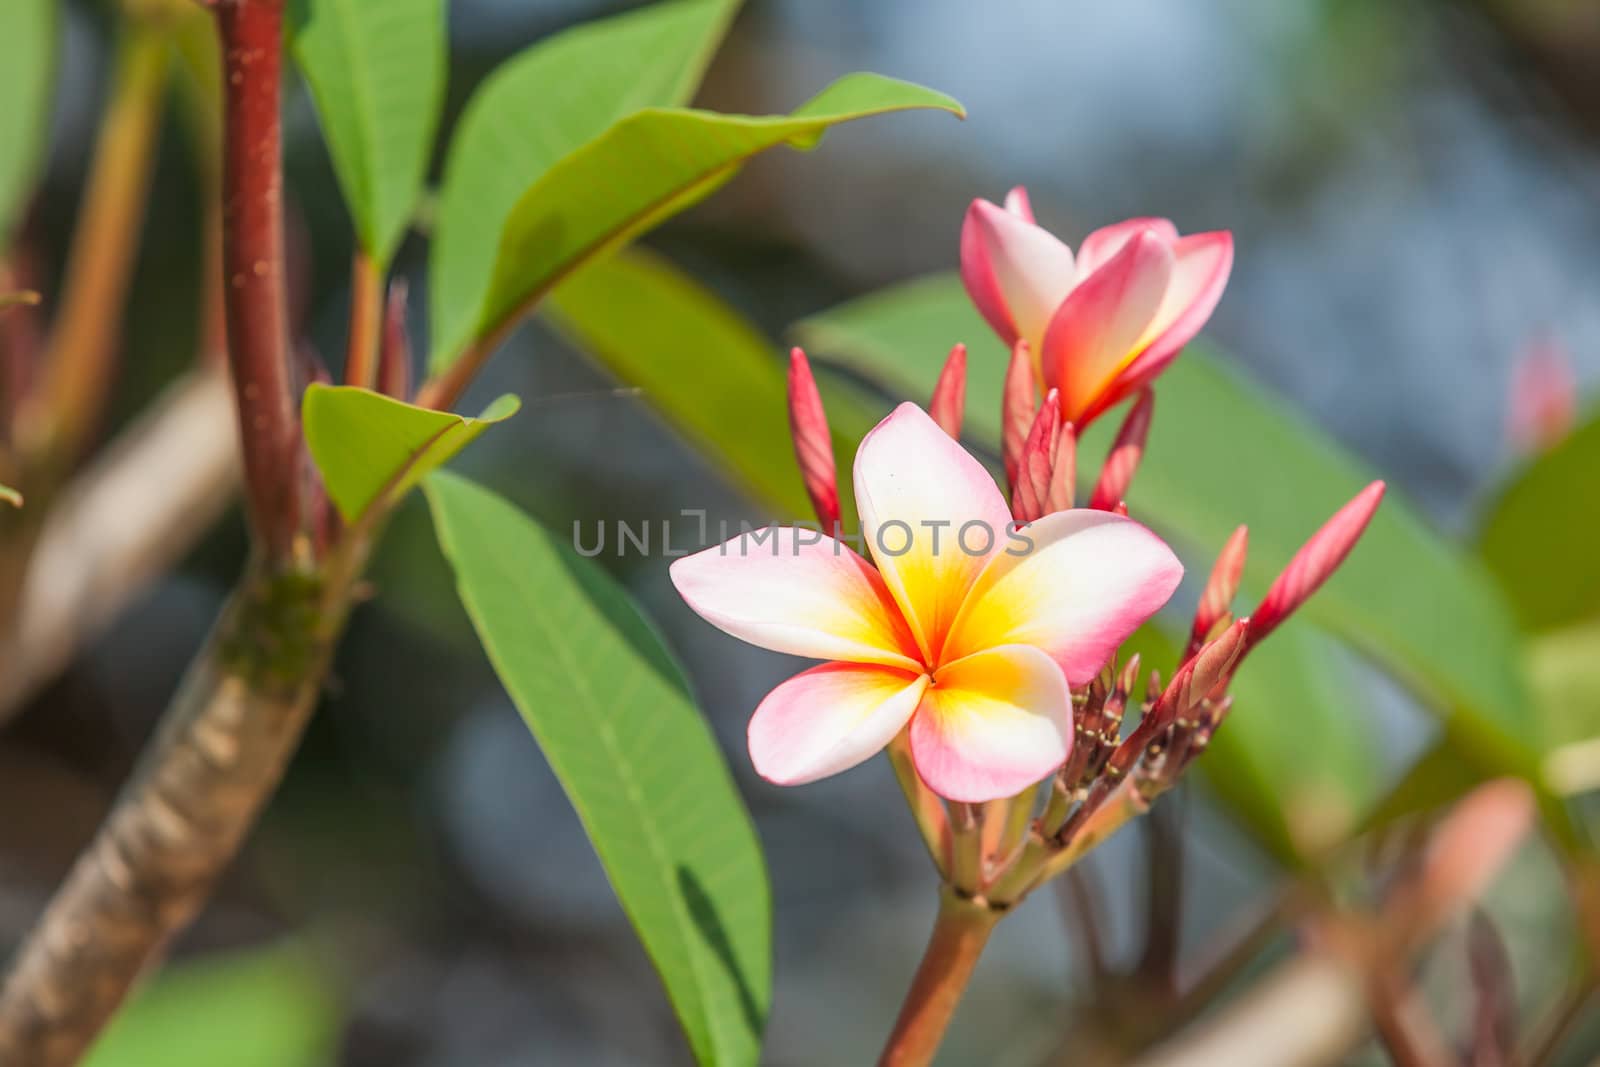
[0,560,354,1067]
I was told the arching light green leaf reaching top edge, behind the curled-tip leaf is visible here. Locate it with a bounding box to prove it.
[429,0,739,363]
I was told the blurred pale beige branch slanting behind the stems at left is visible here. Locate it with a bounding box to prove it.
[0,366,238,723]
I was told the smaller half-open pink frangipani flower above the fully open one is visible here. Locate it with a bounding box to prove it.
[962,186,1234,429]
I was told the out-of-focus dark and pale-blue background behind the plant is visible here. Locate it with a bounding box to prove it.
[0,0,1600,1067]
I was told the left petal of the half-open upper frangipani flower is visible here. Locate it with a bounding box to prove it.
[962,200,1077,352]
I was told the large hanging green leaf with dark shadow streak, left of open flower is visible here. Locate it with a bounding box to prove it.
[424,474,771,1064]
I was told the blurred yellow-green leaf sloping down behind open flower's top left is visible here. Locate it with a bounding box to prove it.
[544,248,882,518]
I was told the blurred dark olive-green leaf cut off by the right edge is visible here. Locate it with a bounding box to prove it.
[1478,418,1600,630]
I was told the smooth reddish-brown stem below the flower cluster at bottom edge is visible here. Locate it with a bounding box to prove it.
[878,886,1003,1067]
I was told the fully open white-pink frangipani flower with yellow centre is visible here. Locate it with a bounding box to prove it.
[672,403,1182,801]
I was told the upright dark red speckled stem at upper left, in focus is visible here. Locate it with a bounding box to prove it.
[214,0,299,561]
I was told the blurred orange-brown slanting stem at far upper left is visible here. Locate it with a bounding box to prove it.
[19,18,168,470]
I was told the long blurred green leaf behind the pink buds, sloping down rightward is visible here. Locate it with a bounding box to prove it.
[798,275,1538,773]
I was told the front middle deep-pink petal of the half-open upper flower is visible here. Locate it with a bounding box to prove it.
[1042,230,1173,427]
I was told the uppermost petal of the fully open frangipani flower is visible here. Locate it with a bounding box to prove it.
[856,403,1011,662]
